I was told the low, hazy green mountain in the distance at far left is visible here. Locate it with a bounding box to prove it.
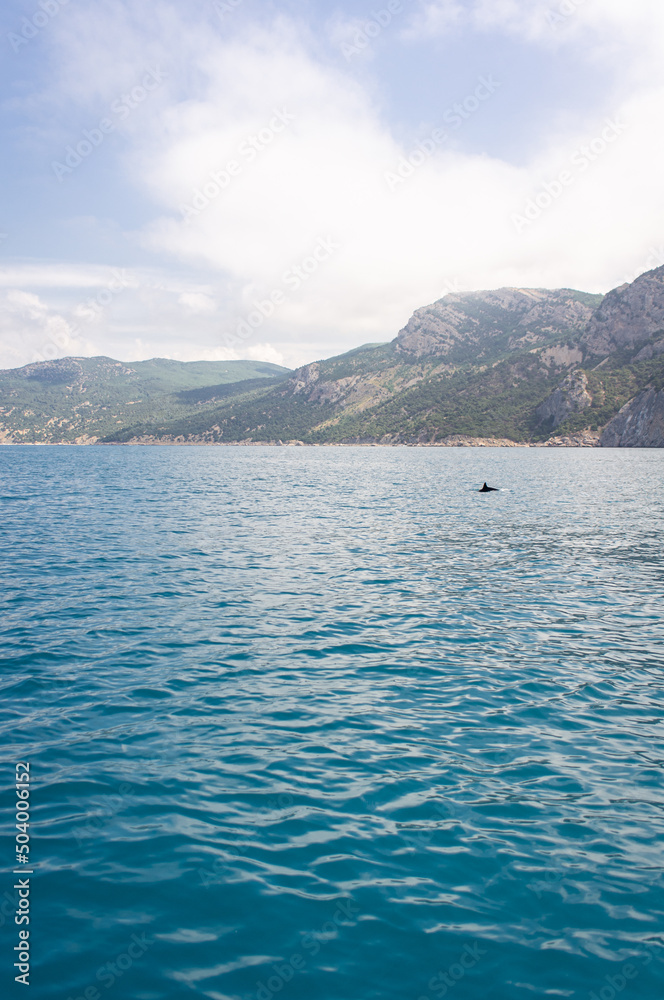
[0,357,290,444]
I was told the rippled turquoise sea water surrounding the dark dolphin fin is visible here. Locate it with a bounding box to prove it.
[0,447,664,1000]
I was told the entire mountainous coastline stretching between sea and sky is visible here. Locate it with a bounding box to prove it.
[0,267,664,447]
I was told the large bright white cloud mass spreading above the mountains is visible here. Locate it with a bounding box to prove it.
[0,0,664,374]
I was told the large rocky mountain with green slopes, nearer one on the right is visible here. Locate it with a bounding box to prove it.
[100,268,664,445]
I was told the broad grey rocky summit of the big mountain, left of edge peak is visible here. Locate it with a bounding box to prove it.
[396,288,592,358]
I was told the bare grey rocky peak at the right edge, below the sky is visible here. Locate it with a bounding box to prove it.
[581,267,664,355]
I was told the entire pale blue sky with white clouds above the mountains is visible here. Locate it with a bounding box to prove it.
[0,0,664,368]
